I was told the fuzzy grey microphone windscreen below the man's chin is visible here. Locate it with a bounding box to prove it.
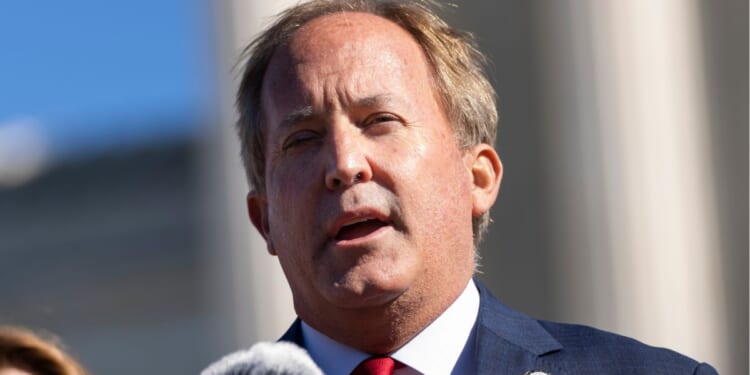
[201,341,323,375]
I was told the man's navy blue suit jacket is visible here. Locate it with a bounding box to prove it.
[280,281,716,375]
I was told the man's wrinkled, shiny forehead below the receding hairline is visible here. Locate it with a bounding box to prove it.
[262,12,438,108]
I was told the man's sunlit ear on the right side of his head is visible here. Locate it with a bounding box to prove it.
[466,143,503,217]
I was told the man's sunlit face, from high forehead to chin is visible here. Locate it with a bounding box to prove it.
[248,13,502,326]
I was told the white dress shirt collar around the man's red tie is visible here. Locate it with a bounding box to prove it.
[302,280,479,375]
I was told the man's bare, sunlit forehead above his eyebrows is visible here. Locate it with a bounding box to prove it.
[262,12,432,115]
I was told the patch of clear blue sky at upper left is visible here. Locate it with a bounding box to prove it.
[0,0,218,157]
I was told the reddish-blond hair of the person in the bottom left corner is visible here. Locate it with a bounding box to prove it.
[0,326,86,375]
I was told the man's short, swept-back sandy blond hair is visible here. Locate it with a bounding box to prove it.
[236,0,497,245]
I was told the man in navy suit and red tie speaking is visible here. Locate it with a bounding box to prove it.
[237,0,715,374]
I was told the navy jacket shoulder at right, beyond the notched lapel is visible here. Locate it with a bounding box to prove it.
[539,321,717,375]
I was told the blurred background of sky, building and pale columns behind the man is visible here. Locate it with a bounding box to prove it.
[0,0,748,375]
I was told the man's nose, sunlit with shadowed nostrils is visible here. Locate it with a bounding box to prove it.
[325,130,372,190]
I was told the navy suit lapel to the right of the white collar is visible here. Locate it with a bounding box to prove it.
[475,280,562,375]
